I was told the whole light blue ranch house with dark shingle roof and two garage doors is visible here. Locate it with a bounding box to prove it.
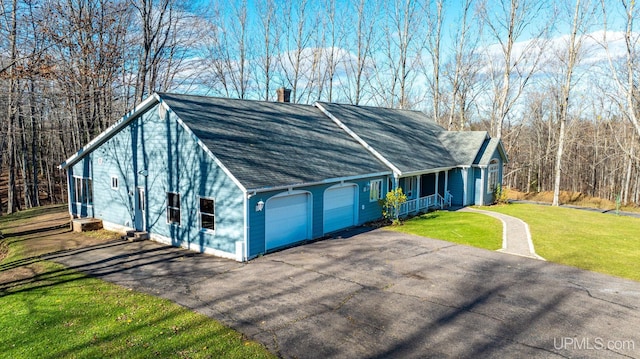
[60,88,507,261]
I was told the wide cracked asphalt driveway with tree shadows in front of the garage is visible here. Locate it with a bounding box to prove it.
[51,230,640,358]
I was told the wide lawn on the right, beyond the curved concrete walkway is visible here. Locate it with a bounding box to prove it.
[483,204,640,281]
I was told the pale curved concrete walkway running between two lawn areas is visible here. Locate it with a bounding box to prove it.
[459,207,544,260]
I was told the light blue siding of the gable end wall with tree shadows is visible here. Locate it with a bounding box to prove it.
[70,105,244,253]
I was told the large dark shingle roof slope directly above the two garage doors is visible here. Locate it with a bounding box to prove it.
[159,93,389,189]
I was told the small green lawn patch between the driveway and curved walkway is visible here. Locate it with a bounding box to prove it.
[387,211,502,250]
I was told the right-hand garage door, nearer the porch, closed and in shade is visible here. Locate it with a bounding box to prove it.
[324,185,357,233]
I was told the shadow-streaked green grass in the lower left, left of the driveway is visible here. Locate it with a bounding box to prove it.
[0,208,273,358]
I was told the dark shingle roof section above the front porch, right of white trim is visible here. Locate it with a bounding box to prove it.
[320,102,460,173]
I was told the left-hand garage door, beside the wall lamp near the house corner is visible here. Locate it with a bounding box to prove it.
[265,193,311,250]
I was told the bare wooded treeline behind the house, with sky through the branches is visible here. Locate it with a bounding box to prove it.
[0,0,640,214]
